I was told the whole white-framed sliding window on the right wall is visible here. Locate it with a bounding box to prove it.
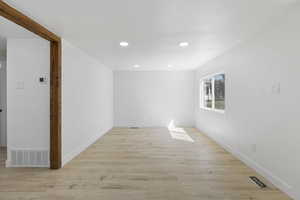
[200,74,225,112]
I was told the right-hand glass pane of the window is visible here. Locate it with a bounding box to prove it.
[214,74,225,110]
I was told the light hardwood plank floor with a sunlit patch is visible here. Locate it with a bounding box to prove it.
[0,128,289,200]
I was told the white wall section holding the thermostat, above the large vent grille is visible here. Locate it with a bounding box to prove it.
[7,39,50,150]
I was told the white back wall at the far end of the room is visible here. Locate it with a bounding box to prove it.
[114,71,194,127]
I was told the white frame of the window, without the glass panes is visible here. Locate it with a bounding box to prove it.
[199,72,226,113]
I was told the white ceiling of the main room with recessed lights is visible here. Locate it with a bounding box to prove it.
[2,0,298,70]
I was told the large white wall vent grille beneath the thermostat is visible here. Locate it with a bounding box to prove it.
[9,150,49,167]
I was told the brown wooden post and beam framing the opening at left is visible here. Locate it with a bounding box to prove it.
[0,1,62,169]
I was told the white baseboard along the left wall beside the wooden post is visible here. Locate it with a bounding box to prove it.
[62,127,112,167]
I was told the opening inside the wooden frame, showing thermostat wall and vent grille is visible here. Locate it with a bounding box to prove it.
[0,17,51,168]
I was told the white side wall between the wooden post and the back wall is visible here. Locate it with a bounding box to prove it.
[62,40,113,164]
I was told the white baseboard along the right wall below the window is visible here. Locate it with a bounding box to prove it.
[197,128,300,200]
